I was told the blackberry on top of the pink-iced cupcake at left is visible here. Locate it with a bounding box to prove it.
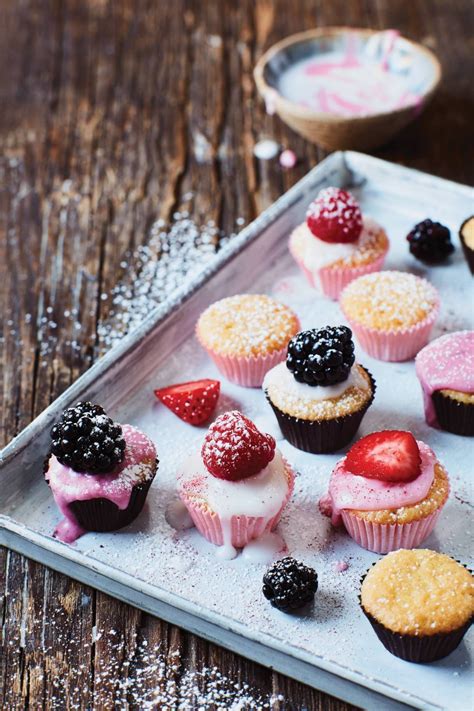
[51,402,125,474]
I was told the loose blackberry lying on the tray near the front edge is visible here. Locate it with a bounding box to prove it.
[262,556,318,612]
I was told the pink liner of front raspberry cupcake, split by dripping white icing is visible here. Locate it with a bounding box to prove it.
[180,462,295,548]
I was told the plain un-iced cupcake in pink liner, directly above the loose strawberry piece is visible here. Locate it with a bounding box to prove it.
[196,294,299,388]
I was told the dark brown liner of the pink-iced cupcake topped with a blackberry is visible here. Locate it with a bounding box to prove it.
[69,470,156,533]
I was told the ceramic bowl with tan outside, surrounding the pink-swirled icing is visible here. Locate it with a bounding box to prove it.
[254,27,441,150]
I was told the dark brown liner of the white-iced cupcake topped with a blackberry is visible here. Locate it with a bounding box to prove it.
[265,368,376,454]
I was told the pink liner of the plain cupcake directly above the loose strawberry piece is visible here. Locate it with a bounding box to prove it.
[201,342,287,388]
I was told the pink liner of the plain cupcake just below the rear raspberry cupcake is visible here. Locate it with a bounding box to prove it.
[342,301,439,362]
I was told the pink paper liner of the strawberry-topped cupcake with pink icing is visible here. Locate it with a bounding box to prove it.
[341,504,444,553]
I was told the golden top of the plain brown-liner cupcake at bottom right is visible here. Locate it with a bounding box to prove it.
[361,549,474,636]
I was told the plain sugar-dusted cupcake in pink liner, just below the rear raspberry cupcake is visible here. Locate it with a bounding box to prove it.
[340,271,439,361]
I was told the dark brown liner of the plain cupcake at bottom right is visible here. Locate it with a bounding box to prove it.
[359,561,473,664]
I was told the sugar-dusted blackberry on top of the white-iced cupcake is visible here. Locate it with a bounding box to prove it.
[286,326,355,386]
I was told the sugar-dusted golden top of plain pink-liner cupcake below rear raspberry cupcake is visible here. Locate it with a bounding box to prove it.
[340,271,438,332]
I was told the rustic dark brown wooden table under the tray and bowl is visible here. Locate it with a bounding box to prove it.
[0,0,474,709]
